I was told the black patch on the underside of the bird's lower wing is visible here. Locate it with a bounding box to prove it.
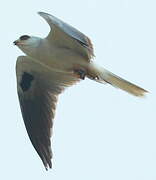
[20,72,34,91]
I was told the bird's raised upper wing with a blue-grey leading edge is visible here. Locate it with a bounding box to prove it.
[38,12,94,59]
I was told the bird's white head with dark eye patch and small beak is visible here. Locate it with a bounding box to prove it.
[13,35,41,55]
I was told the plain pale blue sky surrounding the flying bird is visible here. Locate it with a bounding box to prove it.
[0,0,156,180]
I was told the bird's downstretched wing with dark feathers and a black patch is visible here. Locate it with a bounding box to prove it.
[16,56,78,169]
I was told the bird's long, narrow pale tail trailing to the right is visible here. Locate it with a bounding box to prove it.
[88,63,148,96]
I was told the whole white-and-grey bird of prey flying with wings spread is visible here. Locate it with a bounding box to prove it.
[13,12,148,170]
